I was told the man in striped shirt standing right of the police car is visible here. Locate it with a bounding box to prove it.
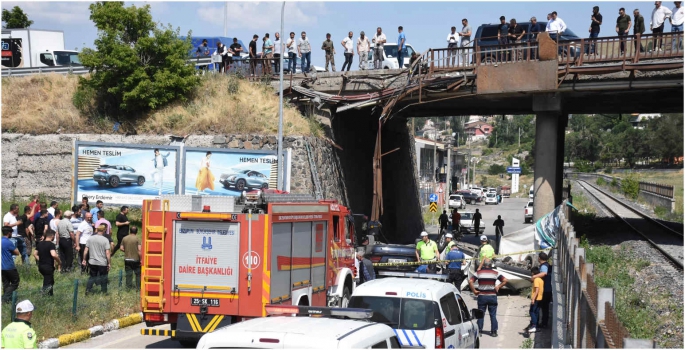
[469,259,507,337]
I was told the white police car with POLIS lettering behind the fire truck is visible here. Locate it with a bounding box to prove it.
[349,273,483,349]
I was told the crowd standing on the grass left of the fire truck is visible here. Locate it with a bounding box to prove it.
[2,196,141,302]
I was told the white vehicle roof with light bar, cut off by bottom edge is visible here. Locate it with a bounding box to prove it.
[197,305,400,349]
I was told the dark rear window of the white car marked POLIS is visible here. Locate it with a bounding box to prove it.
[349,296,434,330]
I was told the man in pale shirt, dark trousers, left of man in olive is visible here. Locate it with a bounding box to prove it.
[81,226,111,295]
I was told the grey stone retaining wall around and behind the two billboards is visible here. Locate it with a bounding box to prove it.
[1,134,348,205]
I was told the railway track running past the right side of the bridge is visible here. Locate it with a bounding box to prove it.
[575,180,683,271]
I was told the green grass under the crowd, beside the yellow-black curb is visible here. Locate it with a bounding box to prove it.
[2,199,141,341]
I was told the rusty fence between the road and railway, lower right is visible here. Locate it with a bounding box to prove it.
[552,205,655,349]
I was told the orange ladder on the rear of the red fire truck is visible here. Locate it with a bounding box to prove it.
[142,199,169,312]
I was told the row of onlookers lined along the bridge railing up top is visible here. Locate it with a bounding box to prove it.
[196,1,685,75]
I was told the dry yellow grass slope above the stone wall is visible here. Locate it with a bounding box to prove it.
[2,74,321,136]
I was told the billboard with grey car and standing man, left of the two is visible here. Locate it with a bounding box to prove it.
[72,141,180,206]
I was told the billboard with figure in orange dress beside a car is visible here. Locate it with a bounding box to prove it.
[181,148,280,196]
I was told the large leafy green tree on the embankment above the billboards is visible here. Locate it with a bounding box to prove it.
[74,2,200,118]
